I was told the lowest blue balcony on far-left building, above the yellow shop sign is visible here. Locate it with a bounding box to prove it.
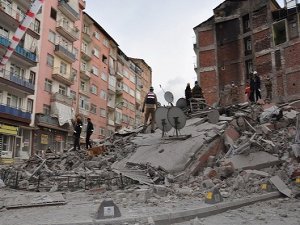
[0,103,31,124]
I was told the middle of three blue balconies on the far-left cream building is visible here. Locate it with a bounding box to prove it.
[0,69,34,95]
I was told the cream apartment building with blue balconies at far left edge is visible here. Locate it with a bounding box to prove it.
[0,0,40,158]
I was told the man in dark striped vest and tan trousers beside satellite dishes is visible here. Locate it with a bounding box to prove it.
[142,87,157,133]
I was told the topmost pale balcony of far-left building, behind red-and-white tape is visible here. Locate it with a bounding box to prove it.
[0,0,40,39]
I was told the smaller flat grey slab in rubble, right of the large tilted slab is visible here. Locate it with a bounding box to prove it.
[224,152,281,170]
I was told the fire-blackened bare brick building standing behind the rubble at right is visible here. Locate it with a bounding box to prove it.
[194,0,300,105]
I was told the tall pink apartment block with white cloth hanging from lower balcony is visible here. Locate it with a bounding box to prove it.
[33,0,85,152]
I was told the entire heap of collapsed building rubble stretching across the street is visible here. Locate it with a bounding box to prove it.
[0,100,300,213]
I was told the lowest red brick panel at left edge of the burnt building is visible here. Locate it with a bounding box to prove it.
[200,71,219,104]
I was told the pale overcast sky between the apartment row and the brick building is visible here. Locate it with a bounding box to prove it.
[86,0,284,104]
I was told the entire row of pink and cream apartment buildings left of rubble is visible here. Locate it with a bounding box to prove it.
[0,0,151,159]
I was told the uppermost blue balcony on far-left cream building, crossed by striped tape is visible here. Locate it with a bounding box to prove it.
[0,36,37,67]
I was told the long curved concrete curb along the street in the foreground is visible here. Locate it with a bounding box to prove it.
[45,192,281,225]
